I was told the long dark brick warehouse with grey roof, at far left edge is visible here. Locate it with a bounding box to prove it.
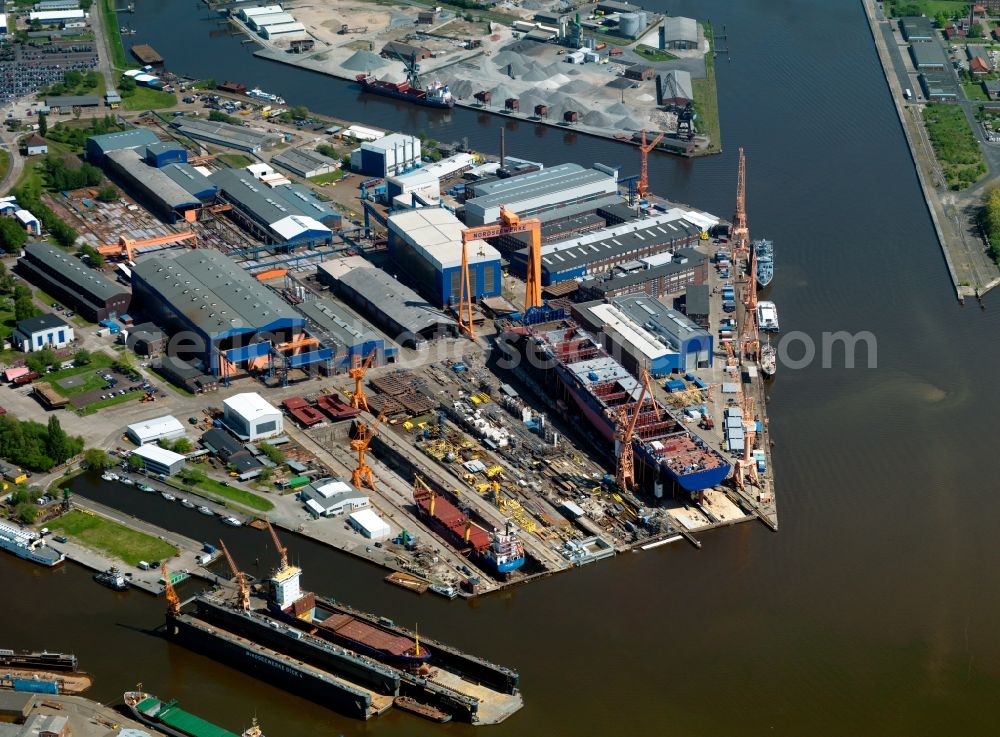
[17,242,132,322]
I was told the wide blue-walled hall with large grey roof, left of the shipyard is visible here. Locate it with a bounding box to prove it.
[132,248,314,375]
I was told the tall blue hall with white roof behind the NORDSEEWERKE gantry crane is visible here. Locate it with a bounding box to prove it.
[389,207,501,305]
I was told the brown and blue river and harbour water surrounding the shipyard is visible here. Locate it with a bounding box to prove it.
[0,0,1000,737]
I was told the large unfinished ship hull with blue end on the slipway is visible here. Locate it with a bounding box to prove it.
[504,310,732,498]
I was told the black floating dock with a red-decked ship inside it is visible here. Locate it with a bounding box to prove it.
[164,528,522,725]
